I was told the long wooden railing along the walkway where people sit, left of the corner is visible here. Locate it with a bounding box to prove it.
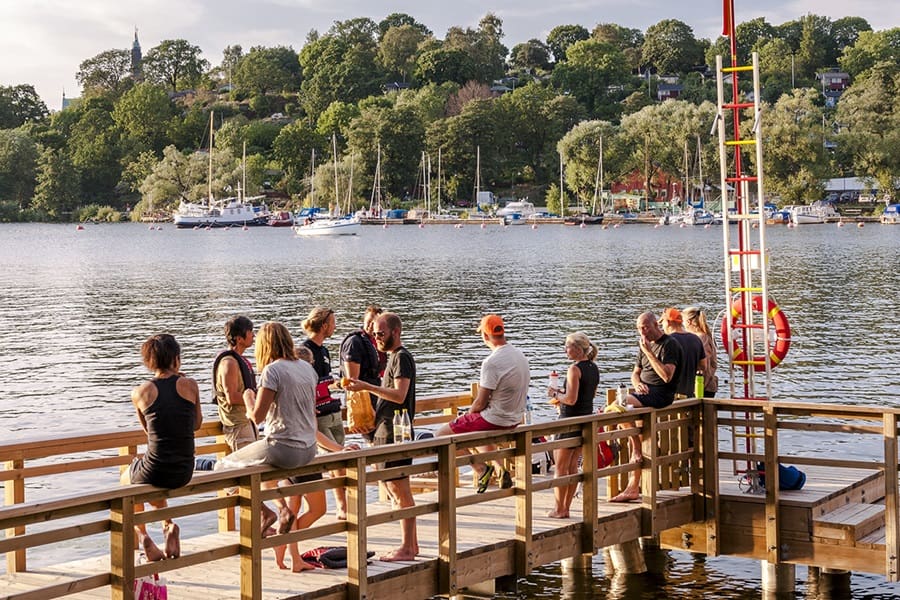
[0,394,699,599]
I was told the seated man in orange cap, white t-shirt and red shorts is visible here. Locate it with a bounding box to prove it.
[435,315,531,494]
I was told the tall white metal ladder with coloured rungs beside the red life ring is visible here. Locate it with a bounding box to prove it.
[716,50,772,492]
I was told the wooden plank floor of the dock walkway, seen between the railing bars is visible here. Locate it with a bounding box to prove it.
[0,477,691,600]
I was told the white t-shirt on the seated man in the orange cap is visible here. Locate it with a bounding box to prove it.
[479,344,531,427]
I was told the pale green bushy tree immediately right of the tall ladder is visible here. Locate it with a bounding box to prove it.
[756,88,828,204]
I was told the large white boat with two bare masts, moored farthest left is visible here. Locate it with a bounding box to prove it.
[172,111,269,229]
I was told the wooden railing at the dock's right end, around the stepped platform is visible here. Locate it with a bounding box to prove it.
[702,399,900,581]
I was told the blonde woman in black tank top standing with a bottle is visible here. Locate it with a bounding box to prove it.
[547,331,600,519]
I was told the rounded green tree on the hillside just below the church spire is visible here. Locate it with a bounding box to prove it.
[112,83,174,156]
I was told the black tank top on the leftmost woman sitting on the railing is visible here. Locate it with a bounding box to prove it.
[142,375,195,488]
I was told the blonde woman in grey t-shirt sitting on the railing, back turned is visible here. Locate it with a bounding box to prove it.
[221,322,343,571]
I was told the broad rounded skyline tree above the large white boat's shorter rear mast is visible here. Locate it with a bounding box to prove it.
[233,46,301,96]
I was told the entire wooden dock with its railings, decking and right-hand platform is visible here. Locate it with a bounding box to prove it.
[0,394,898,600]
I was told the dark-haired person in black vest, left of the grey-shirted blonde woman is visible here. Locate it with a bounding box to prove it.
[213,315,259,452]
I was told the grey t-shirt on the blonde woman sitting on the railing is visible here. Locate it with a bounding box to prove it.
[259,358,319,448]
